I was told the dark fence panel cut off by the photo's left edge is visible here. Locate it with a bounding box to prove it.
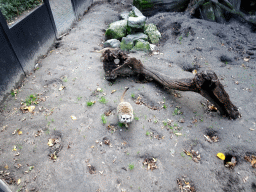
[0,22,24,101]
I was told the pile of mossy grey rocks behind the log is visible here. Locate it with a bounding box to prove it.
[104,6,161,52]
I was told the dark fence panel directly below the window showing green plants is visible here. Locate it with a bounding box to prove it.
[10,4,55,72]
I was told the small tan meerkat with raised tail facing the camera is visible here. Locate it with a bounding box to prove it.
[117,87,133,127]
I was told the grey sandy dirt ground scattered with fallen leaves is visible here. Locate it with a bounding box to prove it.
[0,0,256,192]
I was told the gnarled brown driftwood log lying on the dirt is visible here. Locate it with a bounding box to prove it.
[103,49,241,119]
